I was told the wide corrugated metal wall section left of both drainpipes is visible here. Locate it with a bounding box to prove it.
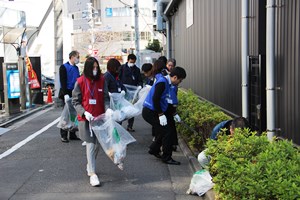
[172,0,242,115]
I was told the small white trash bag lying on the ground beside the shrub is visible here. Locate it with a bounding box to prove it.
[186,169,214,196]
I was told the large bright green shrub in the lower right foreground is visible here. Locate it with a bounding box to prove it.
[206,129,300,200]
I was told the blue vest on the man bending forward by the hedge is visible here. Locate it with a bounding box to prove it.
[143,76,170,112]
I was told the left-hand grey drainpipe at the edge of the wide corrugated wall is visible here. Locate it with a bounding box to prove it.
[242,0,249,119]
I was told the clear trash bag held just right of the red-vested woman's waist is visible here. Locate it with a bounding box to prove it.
[109,93,139,122]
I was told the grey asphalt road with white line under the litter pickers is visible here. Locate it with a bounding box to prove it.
[0,107,202,200]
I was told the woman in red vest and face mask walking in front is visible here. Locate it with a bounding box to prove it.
[72,57,109,186]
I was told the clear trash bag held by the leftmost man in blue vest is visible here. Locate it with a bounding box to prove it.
[57,98,78,132]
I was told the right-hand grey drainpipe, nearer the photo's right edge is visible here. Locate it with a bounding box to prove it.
[266,0,276,141]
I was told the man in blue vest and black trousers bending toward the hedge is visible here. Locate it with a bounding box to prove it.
[142,66,186,165]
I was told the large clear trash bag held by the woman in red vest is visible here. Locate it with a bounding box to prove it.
[91,113,136,170]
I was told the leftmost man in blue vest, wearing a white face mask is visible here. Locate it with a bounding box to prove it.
[58,50,80,143]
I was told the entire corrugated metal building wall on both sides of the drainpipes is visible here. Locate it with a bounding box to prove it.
[171,0,300,144]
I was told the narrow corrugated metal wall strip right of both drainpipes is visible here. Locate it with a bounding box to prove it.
[275,0,300,144]
